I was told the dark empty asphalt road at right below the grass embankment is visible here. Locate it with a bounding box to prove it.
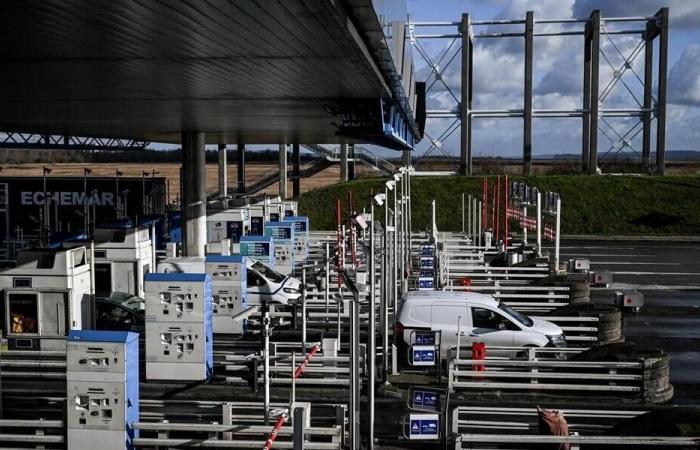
[548,241,700,405]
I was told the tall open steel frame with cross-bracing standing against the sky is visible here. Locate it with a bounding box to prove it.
[409,8,669,175]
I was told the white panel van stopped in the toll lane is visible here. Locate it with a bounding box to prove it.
[396,291,566,359]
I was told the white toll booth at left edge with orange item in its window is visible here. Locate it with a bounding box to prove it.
[0,246,93,350]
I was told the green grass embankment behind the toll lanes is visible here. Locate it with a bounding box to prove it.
[299,175,700,235]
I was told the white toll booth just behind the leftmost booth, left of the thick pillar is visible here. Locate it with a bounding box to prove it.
[95,227,155,298]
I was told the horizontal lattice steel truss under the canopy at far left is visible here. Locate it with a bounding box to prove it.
[0,132,150,150]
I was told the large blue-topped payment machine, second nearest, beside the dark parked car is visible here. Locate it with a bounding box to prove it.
[146,273,214,381]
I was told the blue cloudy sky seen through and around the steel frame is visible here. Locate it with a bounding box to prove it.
[408,0,700,161]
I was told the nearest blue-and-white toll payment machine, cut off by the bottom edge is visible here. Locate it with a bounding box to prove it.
[66,330,139,450]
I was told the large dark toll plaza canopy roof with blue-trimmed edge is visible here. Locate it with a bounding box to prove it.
[0,0,420,149]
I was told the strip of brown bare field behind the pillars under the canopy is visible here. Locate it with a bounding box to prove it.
[0,163,370,201]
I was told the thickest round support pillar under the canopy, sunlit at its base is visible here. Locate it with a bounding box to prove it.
[182,131,207,256]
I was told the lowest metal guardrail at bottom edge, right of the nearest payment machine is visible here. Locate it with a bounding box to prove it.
[132,422,342,450]
